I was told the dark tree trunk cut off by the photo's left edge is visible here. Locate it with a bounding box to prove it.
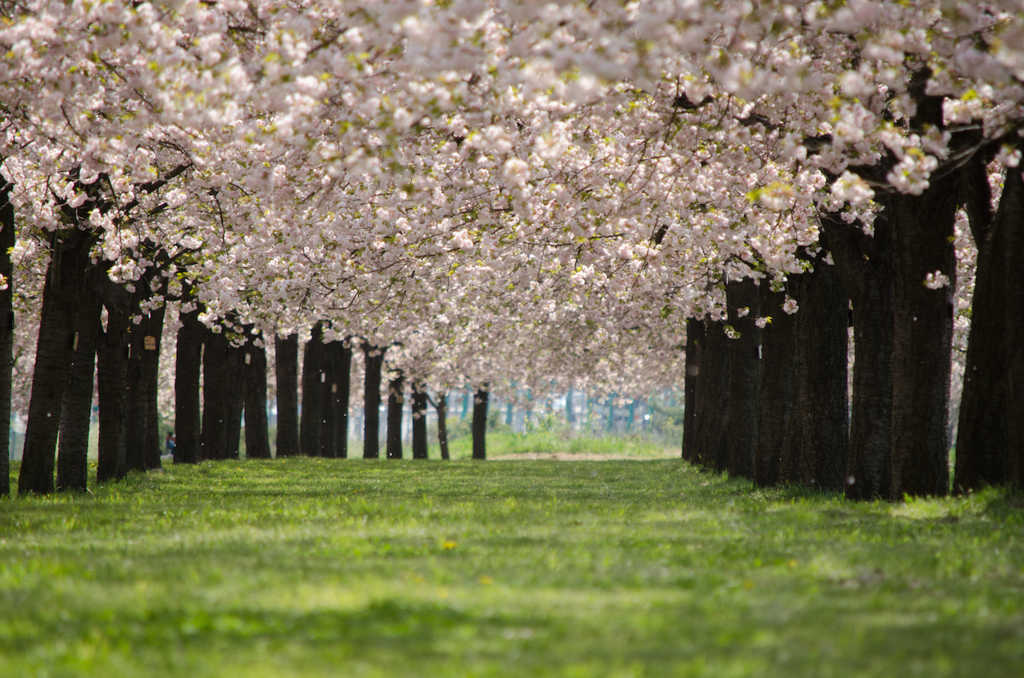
[0,175,15,497]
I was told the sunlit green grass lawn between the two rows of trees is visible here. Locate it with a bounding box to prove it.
[0,459,1024,678]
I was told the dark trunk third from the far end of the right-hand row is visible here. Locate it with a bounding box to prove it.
[725,278,761,478]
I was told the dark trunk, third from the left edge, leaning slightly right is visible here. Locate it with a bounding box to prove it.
[57,273,102,492]
